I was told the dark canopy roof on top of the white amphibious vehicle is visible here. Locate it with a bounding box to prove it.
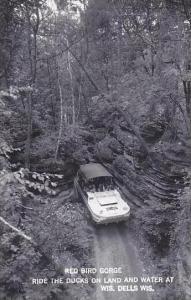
[80,163,113,180]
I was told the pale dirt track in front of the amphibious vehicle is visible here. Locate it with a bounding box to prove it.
[94,224,151,300]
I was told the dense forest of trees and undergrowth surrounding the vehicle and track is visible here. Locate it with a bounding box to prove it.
[0,0,191,300]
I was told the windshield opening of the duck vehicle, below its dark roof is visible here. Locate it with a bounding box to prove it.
[87,176,115,193]
